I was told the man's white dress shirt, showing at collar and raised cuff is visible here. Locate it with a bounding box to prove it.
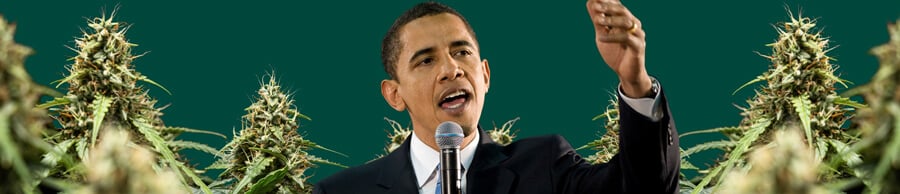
[409,83,663,194]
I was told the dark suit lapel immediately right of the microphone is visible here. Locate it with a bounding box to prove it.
[466,127,517,193]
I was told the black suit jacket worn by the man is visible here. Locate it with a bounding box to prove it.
[313,91,681,194]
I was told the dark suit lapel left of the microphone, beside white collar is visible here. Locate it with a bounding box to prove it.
[376,136,419,193]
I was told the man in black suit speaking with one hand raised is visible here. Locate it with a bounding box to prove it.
[314,0,680,194]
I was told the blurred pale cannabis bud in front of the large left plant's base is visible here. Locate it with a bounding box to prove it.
[75,130,188,194]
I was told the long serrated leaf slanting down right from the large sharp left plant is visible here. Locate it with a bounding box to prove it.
[132,119,212,194]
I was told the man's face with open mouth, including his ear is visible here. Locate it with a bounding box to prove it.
[382,13,490,135]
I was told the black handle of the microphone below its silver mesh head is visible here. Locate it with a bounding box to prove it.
[440,148,462,194]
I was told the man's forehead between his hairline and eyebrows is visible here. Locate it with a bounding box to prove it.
[399,13,475,53]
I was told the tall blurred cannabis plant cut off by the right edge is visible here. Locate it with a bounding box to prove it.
[849,20,900,193]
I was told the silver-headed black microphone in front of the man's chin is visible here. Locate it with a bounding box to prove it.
[434,121,465,194]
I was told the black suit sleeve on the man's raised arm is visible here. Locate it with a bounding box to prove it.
[551,88,681,193]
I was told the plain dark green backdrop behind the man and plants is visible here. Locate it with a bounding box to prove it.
[0,0,900,181]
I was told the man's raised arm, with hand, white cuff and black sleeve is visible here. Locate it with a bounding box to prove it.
[576,0,681,193]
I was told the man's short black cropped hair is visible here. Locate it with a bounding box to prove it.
[381,2,478,80]
